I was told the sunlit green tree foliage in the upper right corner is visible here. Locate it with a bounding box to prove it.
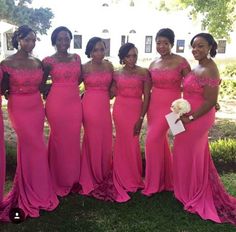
[177,0,236,39]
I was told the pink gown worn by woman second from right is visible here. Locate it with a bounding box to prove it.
[142,60,189,196]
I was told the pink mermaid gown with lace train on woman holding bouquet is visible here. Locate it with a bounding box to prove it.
[173,73,236,225]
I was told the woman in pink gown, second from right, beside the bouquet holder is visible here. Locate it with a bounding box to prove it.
[142,28,190,196]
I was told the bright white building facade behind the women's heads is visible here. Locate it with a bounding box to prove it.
[1,0,236,64]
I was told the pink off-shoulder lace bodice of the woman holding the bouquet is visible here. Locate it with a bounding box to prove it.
[183,72,220,96]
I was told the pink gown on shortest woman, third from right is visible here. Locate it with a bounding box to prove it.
[113,74,148,192]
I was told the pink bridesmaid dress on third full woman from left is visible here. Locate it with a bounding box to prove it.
[80,71,112,194]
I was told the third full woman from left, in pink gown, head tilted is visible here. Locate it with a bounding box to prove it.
[80,37,129,202]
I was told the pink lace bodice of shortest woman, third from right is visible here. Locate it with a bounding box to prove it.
[114,73,150,98]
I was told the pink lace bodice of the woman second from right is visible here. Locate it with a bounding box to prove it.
[150,60,189,90]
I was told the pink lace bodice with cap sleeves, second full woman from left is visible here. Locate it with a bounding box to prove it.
[43,54,81,84]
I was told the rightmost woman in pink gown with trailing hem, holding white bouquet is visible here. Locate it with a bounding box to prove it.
[173,33,236,225]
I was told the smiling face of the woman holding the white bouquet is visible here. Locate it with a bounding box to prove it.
[192,37,211,60]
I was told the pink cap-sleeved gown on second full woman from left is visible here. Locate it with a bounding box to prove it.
[43,55,82,196]
